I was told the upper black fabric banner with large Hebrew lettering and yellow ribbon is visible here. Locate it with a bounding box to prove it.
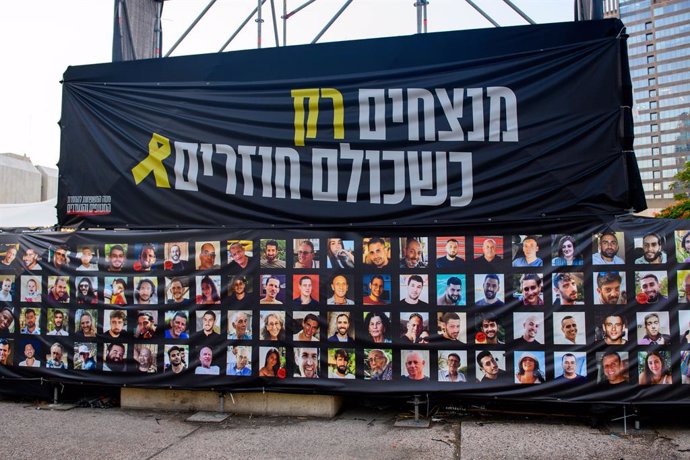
[58,20,645,228]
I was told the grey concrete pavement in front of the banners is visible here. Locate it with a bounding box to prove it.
[0,401,690,460]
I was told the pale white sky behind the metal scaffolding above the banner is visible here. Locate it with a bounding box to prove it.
[0,0,573,166]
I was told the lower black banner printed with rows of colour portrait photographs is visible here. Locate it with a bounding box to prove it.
[0,228,690,397]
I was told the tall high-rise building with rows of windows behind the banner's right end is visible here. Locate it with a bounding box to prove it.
[602,0,690,201]
